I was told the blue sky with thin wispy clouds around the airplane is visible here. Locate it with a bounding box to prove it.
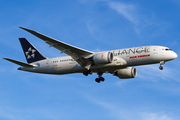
[0,0,180,120]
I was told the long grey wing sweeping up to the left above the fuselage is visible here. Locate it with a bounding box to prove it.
[20,27,93,67]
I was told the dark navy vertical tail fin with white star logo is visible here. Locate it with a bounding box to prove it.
[19,38,46,63]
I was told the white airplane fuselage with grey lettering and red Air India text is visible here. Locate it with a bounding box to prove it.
[19,46,177,74]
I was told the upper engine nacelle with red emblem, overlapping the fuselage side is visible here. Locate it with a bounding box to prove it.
[93,52,113,64]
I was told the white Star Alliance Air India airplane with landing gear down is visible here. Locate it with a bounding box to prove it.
[3,27,177,83]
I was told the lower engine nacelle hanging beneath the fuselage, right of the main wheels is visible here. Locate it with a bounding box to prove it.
[114,67,137,79]
